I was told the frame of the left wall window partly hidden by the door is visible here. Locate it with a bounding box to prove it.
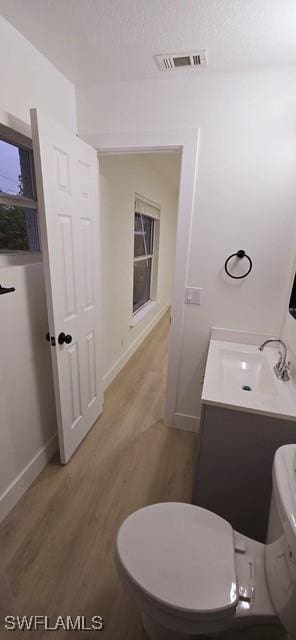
[0,123,41,256]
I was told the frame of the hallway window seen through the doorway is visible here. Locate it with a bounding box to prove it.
[132,194,160,319]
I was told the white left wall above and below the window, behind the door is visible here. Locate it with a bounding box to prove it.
[0,18,76,520]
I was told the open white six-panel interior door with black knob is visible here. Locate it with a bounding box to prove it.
[30,109,102,463]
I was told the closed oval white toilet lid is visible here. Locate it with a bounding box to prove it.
[117,502,238,614]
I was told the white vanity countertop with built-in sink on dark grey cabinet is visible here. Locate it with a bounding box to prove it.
[202,339,296,420]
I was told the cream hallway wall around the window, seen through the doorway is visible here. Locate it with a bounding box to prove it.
[100,154,179,386]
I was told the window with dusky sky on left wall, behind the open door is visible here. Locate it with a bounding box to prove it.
[0,125,40,253]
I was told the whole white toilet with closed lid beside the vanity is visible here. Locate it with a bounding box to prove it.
[117,445,296,640]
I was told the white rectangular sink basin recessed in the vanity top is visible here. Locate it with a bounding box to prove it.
[219,349,277,394]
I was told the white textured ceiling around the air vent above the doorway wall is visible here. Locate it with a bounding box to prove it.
[0,0,296,86]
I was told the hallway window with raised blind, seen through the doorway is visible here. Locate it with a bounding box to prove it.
[133,197,159,313]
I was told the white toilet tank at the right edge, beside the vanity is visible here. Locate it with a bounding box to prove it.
[265,444,296,639]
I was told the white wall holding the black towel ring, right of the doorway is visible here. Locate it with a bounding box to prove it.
[77,70,296,424]
